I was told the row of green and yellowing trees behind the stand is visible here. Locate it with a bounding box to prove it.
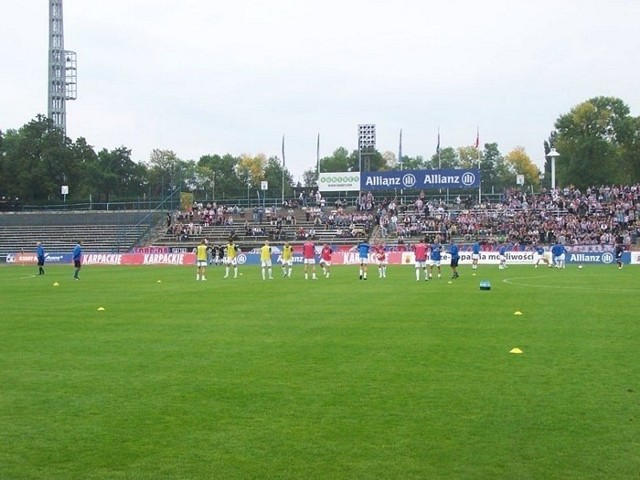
[0,97,640,203]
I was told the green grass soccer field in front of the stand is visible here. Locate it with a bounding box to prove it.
[0,265,640,479]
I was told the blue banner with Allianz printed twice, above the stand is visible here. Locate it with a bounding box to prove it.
[360,168,480,190]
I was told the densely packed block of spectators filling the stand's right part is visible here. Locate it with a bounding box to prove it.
[376,184,640,246]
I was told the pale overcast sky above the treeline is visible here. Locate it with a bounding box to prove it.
[0,0,640,180]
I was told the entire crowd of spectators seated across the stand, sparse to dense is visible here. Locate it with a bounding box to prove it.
[167,184,640,246]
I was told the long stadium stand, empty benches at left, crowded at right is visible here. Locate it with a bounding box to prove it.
[0,185,640,257]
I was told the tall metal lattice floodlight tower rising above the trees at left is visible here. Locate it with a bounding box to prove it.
[48,0,77,135]
